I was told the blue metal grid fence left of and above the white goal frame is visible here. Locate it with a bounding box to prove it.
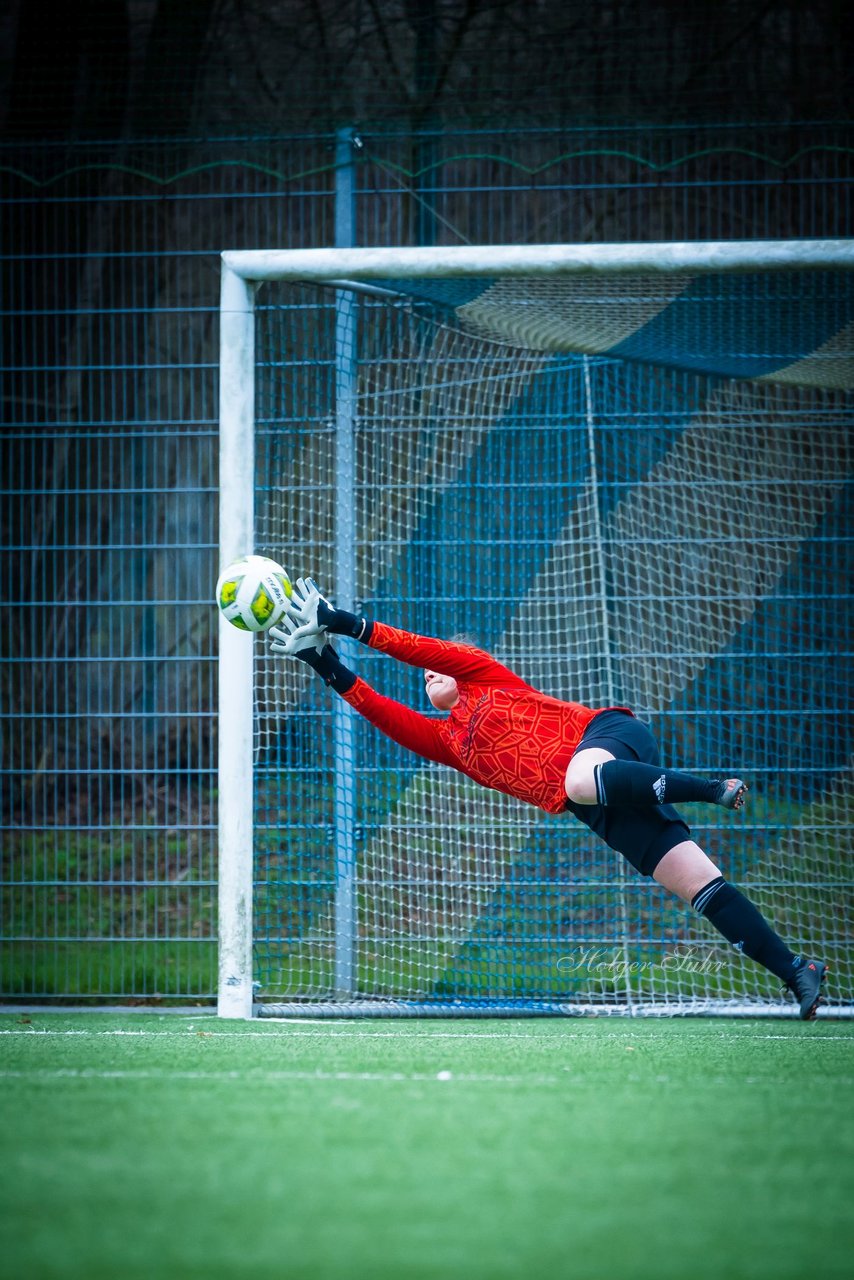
[0,124,854,1001]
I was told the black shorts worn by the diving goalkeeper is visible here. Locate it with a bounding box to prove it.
[566,710,691,876]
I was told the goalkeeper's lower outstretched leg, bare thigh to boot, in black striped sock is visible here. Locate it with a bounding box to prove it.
[652,840,827,1019]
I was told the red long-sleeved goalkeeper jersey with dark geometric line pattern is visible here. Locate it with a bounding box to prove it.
[343,622,627,813]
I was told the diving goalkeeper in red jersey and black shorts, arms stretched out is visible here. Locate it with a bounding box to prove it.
[269,579,827,1019]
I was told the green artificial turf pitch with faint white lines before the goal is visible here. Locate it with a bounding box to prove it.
[0,1010,854,1280]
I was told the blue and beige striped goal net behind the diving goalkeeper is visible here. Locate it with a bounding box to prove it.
[220,246,854,1016]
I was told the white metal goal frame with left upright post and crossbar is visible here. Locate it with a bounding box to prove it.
[218,239,854,1019]
